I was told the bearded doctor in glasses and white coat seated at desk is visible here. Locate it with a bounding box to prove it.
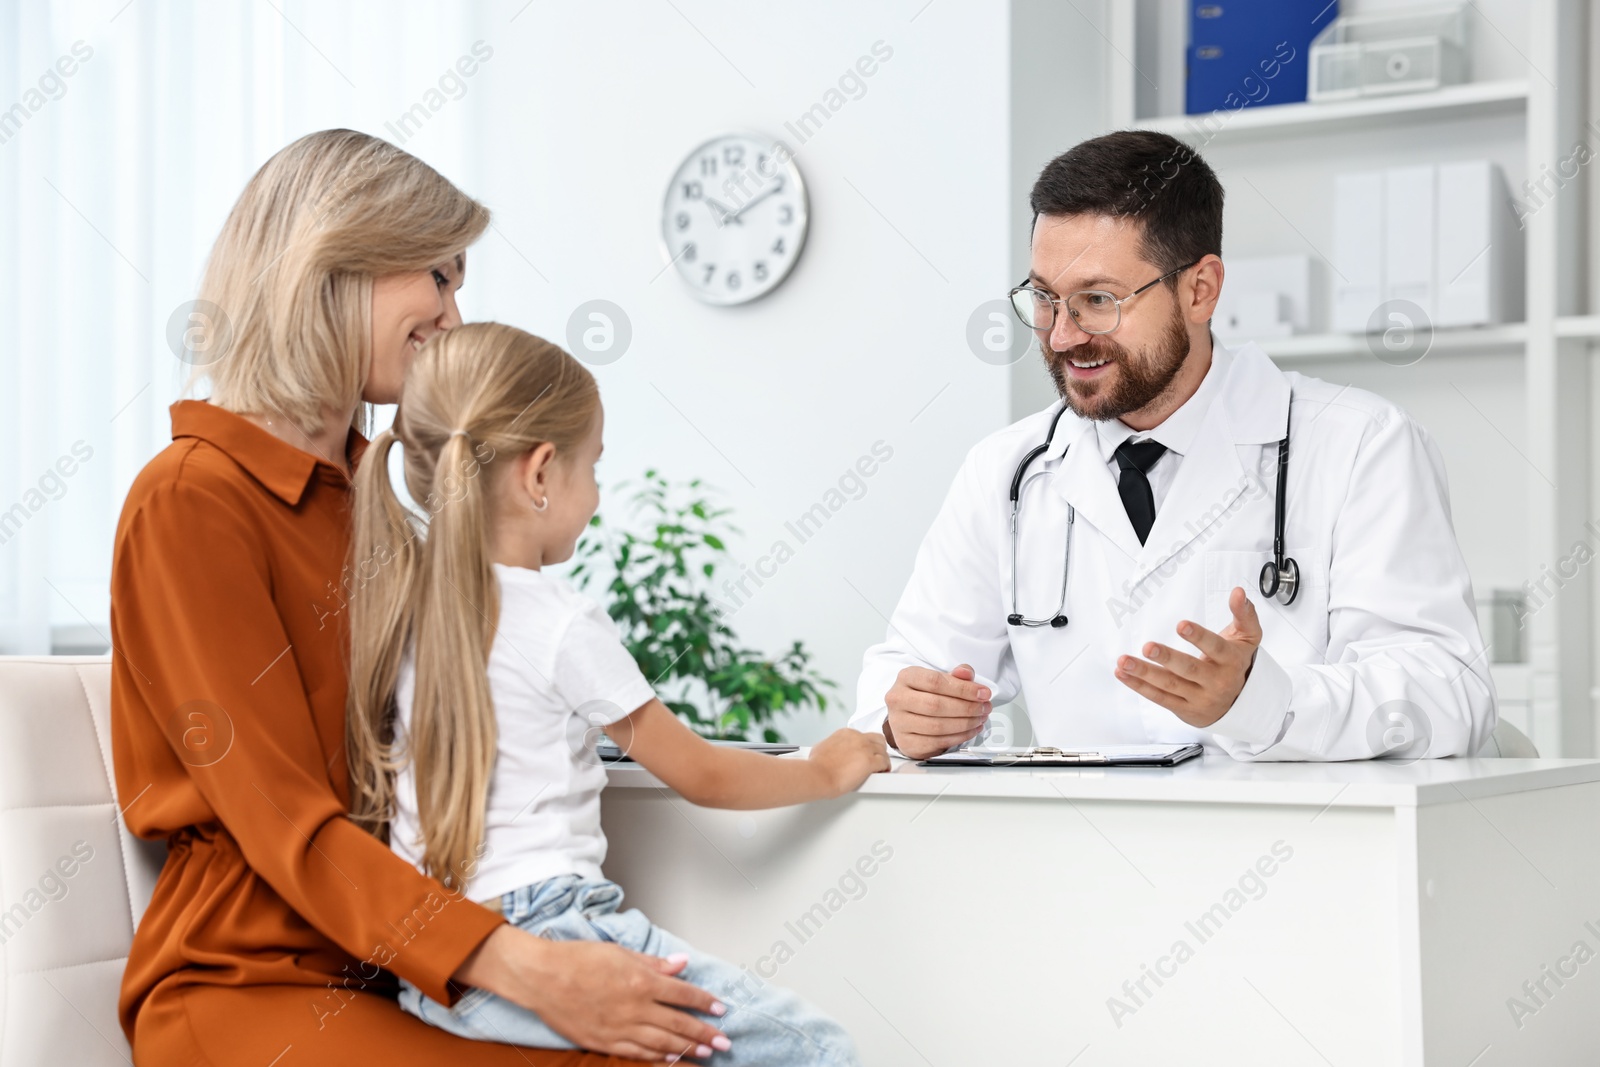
[851,131,1494,760]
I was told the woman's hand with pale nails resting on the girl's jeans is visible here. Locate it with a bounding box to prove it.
[454,925,730,1061]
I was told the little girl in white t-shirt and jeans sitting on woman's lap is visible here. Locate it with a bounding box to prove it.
[349,323,888,1067]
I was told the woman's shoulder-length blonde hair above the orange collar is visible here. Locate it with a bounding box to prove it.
[189,130,490,434]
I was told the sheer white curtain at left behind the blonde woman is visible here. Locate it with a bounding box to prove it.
[0,0,492,653]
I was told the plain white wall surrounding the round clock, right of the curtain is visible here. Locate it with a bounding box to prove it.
[444,0,1013,741]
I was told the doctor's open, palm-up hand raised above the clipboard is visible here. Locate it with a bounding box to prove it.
[1115,585,1261,729]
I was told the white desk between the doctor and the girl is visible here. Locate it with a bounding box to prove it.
[603,753,1600,1067]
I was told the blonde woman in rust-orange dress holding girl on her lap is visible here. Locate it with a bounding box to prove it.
[112,130,732,1067]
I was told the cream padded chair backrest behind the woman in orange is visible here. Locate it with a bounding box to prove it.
[0,656,166,1067]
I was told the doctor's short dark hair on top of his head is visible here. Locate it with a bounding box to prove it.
[1029,130,1222,286]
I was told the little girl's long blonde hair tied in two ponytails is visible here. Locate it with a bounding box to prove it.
[346,323,600,889]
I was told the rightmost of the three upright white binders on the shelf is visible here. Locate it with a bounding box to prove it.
[1434,160,1523,326]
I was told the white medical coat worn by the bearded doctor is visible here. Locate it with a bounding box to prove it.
[851,344,1494,760]
